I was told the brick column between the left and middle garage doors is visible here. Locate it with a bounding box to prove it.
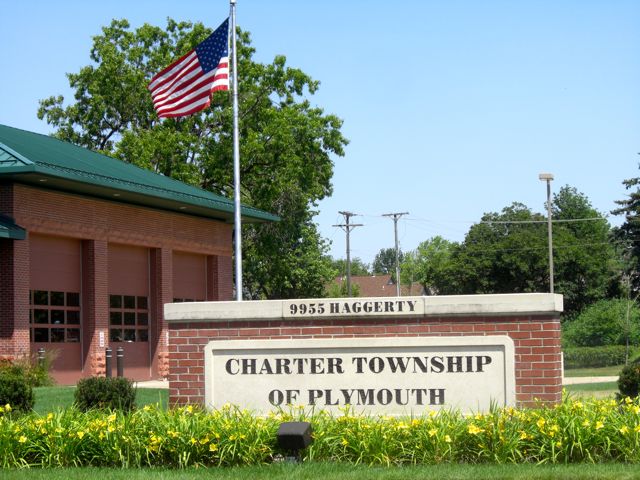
[82,240,109,376]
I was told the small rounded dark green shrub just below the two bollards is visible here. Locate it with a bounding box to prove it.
[74,377,136,412]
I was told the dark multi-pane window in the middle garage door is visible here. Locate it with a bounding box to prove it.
[109,295,149,342]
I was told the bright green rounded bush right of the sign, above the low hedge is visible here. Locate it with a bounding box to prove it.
[562,299,640,347]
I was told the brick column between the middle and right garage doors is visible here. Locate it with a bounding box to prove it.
[149,248,173,378]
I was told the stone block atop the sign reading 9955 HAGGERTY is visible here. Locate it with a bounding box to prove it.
[282,298,424,318]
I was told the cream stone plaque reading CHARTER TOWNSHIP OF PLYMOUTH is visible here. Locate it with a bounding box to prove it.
[204,335,515,415]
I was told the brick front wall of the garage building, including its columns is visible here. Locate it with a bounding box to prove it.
[0,183,233,376]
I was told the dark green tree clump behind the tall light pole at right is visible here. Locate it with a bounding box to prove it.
[450,186,620,316]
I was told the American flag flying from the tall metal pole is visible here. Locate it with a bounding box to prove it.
[147,18,229,118]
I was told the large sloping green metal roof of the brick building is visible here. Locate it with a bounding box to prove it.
[0,125,279,222]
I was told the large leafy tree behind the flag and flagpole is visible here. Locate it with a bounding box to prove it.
[38,19,347,298]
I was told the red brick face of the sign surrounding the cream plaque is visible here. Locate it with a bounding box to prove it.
[169,316,562,406]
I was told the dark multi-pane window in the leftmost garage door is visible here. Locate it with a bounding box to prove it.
[29,290,80,343]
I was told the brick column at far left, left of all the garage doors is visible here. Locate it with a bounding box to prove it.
[0,236,31,359]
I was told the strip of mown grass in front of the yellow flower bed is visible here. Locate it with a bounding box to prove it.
[2,463,640,480]
